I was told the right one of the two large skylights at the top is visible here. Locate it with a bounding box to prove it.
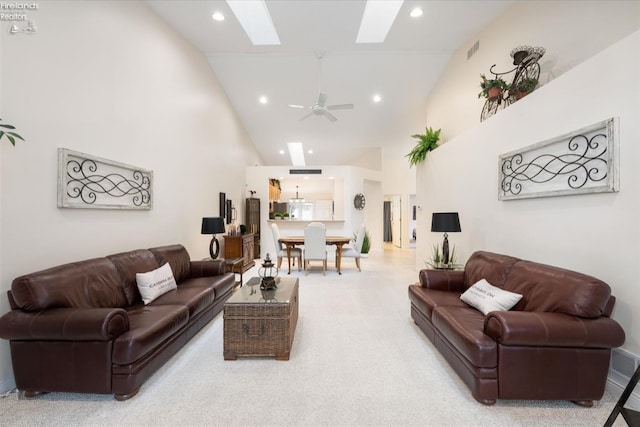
[356,0,404,43]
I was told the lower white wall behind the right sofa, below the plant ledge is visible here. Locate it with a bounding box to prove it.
[416,31,640,362]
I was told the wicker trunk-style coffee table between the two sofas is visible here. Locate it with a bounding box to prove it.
[223,277,298,360]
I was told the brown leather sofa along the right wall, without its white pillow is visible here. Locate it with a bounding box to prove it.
[409,252,625,406]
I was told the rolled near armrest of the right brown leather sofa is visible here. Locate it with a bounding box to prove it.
[484,311,625,348]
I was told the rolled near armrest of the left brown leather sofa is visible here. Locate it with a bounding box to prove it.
[0,308,129,341]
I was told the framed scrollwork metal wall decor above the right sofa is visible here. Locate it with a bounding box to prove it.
[498,118,619,200]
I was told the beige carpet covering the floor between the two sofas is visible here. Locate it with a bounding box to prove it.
[0,246,625,427]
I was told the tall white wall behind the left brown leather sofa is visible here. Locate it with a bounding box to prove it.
[0,1,260,390]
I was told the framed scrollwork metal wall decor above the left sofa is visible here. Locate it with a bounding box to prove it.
[58,148,153,209]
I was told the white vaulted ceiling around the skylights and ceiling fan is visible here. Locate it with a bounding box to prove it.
[147,0,513,165]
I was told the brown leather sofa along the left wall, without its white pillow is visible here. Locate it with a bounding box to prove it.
[0,245,235,400]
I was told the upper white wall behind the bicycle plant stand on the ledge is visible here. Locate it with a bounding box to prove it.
[426,0,640,142]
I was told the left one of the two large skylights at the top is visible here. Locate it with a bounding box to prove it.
[227,0,280,46]
